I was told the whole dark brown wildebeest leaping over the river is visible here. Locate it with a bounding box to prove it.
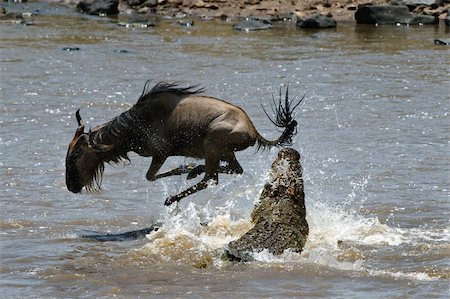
[66,80,303,205]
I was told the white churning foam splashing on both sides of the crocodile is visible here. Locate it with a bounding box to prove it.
[140,173,449,281]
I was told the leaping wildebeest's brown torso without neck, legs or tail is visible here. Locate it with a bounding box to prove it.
[133,93,257,158]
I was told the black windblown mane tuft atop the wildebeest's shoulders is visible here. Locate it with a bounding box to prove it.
[136,80,203,105]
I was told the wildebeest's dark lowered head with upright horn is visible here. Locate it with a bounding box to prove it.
[66,110,112,193]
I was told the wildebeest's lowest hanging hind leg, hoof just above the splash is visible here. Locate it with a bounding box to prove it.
[164,152,220,206]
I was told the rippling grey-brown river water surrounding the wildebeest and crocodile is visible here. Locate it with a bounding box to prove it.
[0,4,450,298]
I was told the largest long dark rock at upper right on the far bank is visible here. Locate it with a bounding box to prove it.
[355,5,437,25]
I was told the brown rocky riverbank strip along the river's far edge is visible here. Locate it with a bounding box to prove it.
[2,0,450,22]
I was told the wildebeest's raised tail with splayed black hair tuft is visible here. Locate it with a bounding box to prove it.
[258,86,305,150]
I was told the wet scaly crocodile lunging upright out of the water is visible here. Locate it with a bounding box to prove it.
[224,148,309,261]
